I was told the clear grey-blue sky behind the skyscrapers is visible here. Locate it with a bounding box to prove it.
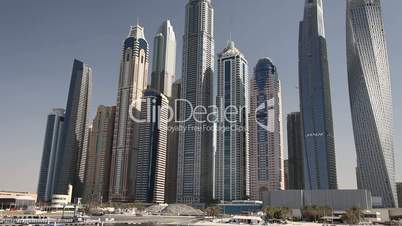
[0,0,402,191]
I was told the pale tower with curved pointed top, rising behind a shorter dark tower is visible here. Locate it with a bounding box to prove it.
[151,20,176,97]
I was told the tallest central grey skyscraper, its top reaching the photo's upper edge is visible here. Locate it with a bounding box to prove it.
[177,0,214,206]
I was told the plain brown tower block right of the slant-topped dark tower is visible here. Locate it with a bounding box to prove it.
[84,105,116,203]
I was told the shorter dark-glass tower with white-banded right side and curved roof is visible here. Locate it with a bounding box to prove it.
[135,89,169,203]
